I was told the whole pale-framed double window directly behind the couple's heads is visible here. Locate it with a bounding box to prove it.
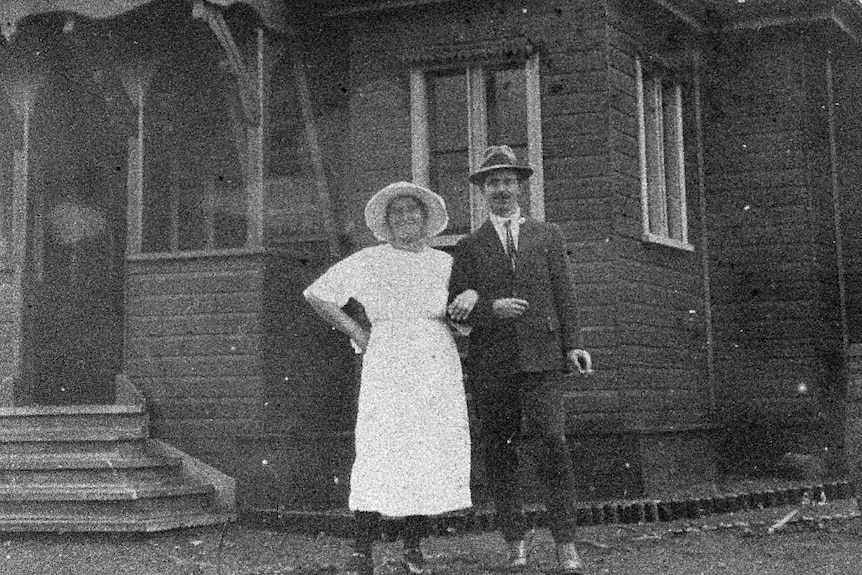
[410,55,544,245]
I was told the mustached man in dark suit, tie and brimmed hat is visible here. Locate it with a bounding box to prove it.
[449,146,592,574]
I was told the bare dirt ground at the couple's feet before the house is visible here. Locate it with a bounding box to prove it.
[0,500,862,575]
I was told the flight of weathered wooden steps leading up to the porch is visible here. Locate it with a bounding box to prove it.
[0,378,236,531]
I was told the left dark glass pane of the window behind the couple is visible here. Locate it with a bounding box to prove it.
[428,71,470,234]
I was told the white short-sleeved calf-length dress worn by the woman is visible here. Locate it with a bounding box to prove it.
[306,244,471,517]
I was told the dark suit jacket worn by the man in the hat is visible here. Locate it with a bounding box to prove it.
[449,219,579,379]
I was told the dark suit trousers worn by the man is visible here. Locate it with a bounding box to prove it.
[471,372,576,543]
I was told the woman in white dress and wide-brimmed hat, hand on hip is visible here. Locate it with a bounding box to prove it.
[304,182,471,575]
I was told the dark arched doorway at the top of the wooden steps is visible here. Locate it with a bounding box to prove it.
[23,63,126,405]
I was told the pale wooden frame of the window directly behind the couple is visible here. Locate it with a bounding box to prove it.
[410,53,545,246]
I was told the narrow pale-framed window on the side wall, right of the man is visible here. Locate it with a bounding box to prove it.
[636,55,693,250]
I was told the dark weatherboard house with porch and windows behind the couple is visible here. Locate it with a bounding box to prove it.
[0,0,862,528]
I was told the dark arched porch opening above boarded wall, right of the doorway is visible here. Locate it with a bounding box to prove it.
[142,50,247,252]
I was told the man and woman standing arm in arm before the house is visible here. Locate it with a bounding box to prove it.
[304,146,591,575]
